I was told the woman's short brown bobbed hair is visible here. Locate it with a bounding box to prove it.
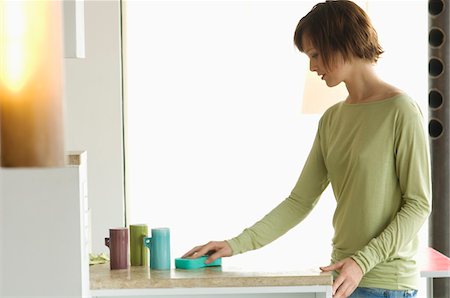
[294,0,383,68]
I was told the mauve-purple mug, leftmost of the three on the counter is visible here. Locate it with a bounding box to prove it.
[105,228,128,270]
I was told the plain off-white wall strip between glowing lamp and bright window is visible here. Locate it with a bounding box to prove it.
[65,0,124,253]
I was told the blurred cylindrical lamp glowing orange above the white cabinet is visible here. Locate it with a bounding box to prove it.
[0,0,64,167]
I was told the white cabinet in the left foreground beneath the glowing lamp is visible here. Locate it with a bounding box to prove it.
[0,153,89,297]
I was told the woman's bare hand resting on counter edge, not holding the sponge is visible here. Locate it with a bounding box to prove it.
[320,258,363,298]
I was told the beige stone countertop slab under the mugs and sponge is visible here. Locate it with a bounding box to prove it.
[90,263,332,290]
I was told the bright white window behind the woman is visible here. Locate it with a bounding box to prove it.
[124,0,428,268]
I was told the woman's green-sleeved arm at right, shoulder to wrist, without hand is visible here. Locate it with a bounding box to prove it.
[352,108,431,274]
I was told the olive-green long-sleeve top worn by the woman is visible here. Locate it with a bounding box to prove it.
[228,94,431,290]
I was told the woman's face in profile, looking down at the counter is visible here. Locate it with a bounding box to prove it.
[302,36,348,87]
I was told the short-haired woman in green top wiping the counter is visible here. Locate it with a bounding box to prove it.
[184,1,430,298]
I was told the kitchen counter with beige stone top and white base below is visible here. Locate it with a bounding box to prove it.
[90,263,332,297]
